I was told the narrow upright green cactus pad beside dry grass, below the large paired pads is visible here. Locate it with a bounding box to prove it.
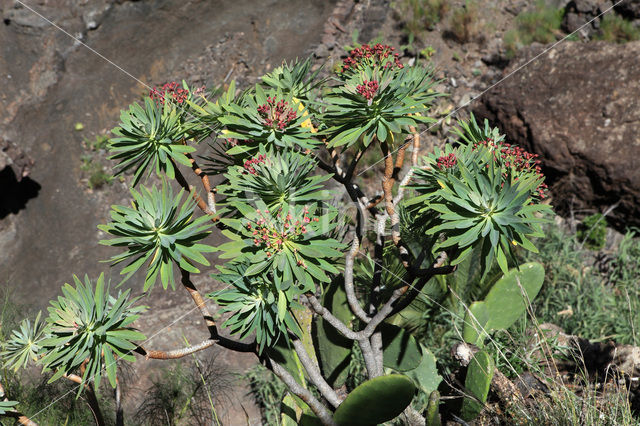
[460,351,495,421]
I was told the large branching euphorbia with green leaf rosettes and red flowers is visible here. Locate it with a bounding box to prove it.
[4,44,548,424]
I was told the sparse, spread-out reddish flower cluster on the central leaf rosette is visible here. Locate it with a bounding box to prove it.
[246,208,319,262]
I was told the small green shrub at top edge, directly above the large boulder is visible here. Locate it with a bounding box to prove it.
[504,0,564,57]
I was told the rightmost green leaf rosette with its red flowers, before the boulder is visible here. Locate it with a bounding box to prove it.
[407,119,550,273]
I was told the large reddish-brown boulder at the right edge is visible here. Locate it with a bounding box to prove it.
[476,42,640,228]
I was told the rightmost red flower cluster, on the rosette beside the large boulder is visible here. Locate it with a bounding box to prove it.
[473,138,549,198]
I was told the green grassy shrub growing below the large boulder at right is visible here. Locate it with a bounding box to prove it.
[527,221,640,344]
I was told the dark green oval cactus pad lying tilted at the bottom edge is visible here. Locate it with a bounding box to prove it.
[333,374,416,426]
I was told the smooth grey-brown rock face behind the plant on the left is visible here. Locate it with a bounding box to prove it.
[0,0,335,425]
